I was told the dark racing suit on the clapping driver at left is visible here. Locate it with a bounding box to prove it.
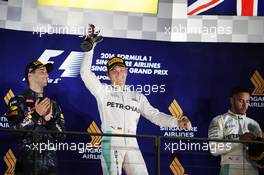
[6,89,65,175]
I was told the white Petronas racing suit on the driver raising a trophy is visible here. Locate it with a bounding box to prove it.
[80,46,178,175]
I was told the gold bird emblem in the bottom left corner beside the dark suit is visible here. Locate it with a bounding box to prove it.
[4,149,16,175]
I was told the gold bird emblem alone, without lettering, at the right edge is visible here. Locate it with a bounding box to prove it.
[250,70,264,96]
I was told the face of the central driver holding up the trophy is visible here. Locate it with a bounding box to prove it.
[108,65,127,86]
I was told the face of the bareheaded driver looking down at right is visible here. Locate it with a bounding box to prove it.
[230,92,250,114]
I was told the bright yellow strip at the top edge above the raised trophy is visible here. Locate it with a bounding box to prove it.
[38,0,159,14]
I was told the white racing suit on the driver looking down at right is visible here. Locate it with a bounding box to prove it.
[208,110,262,175]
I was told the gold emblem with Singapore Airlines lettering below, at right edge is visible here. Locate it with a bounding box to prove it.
[250,70,264,108]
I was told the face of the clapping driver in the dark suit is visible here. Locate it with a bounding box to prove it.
[29,67,49,88]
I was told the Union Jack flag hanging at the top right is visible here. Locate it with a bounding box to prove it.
[188,0,264,16]
